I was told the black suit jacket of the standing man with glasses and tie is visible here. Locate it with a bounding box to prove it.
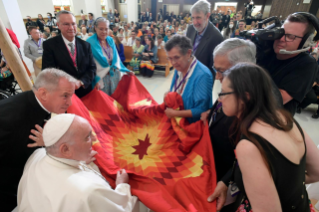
[42,35,96,98]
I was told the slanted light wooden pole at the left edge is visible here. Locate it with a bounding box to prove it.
[0,18,32,91]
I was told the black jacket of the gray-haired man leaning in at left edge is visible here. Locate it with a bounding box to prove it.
[0,91,50,212]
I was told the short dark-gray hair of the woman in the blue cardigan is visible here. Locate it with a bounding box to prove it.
[165,34,193,55]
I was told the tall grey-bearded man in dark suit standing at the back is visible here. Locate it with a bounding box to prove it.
[186,0,223,77]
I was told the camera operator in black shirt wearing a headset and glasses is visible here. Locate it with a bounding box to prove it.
[260,13,318,115]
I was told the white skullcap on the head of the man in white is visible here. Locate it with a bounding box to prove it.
[43,113,75,146]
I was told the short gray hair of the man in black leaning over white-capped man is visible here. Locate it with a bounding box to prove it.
[32,68,77,91]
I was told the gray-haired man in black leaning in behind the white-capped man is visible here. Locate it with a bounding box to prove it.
[0,68,76,212]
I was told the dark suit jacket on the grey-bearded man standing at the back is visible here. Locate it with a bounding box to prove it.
[186,22,224,77]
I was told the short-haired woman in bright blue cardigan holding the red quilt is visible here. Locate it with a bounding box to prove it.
[165,35,213,123]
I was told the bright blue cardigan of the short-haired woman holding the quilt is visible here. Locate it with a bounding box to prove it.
[170,60,214,123]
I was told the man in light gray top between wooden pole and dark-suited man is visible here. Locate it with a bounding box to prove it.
[23,27,45,76]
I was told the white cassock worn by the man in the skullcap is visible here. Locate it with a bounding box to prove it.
[18,148,137,212]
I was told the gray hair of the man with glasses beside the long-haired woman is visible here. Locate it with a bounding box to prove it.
[213,38,256,65]
